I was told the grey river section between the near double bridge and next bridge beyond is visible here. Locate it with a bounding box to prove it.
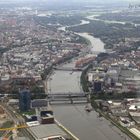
[49,71,81,94]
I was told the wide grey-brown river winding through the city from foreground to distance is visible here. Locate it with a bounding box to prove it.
[48,17,130,140]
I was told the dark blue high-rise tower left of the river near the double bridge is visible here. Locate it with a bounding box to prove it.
[19,90,31,111]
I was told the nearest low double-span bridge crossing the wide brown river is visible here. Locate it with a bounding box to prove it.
[47,93,89,104]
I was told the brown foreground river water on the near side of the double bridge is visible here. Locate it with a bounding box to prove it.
[52,105,131,140]
